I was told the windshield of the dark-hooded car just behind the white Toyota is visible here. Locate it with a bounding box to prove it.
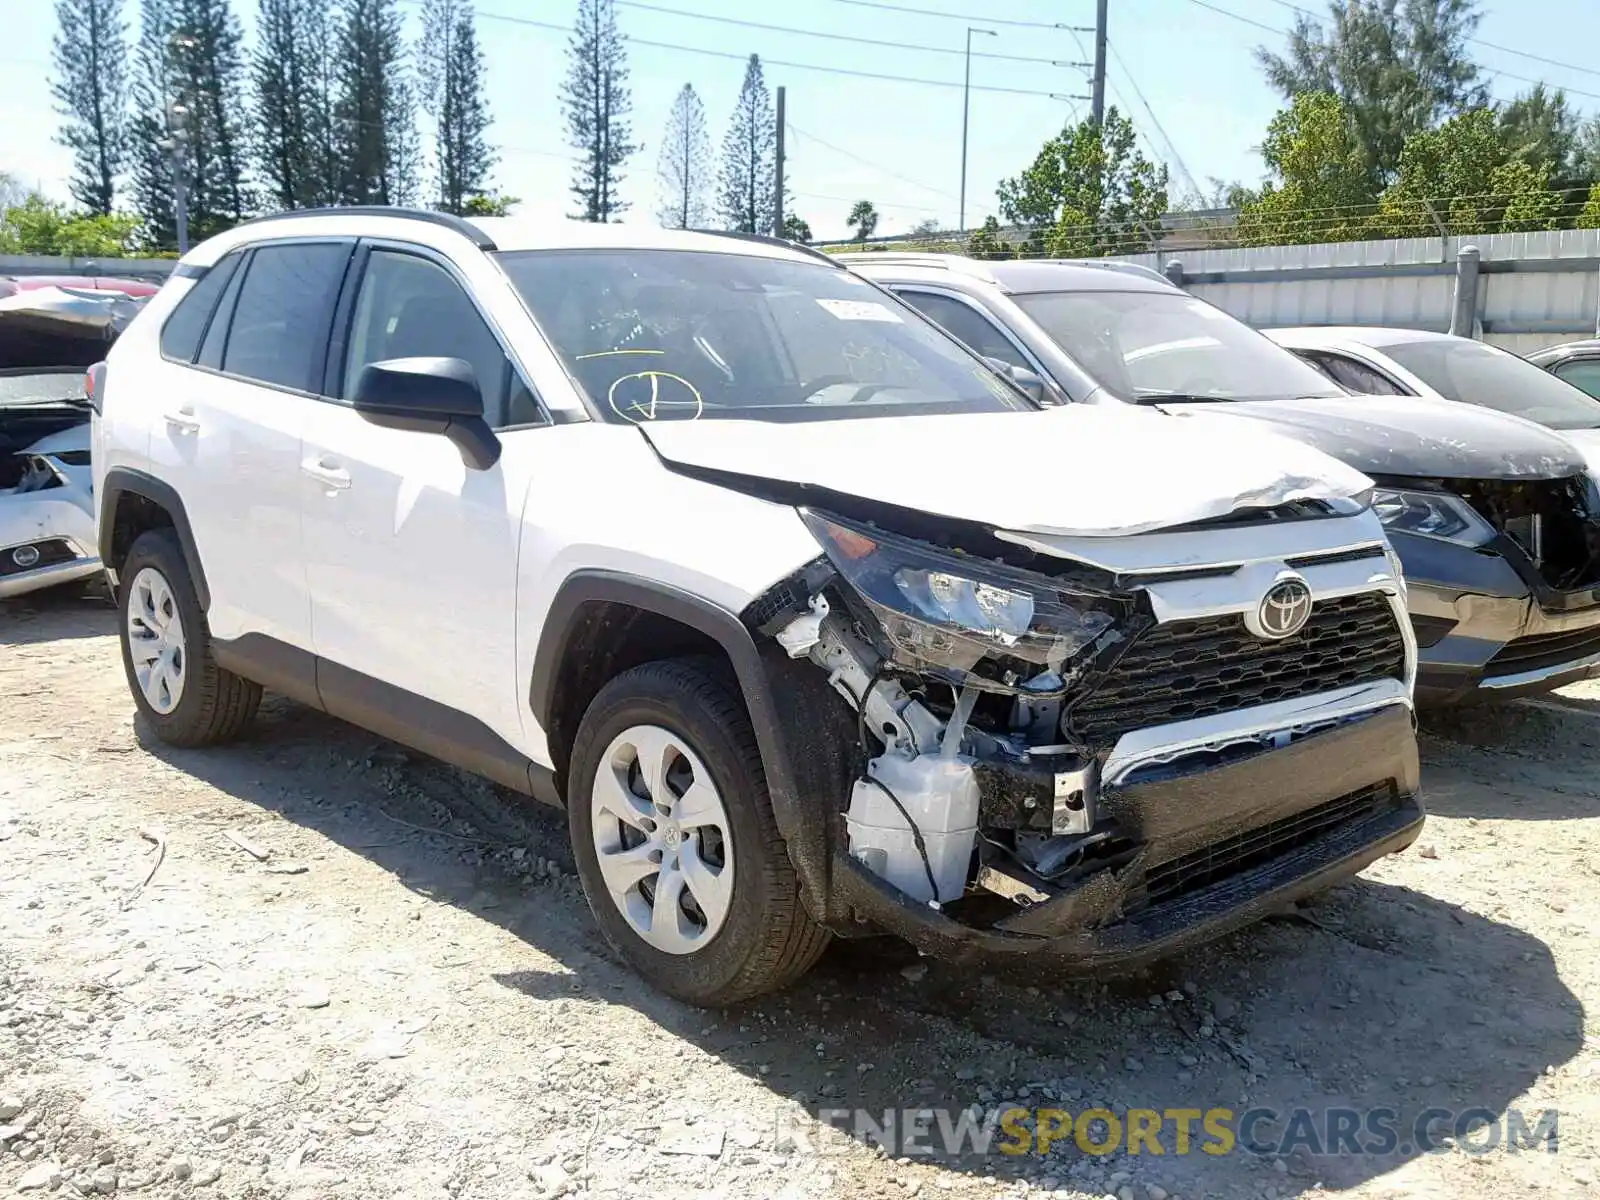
[1013,291,1344,400]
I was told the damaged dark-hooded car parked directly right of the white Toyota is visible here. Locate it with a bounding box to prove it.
[845,253,1600,704]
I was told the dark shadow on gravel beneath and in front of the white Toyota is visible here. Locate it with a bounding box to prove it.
[141,702,1582,1197]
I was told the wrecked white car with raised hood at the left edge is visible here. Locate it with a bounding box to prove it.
[0,288,139,598]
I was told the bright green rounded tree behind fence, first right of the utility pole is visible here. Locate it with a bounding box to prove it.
[1235,91,1376,246]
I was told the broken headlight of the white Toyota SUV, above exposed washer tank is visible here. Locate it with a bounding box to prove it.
[802,510,1120,690]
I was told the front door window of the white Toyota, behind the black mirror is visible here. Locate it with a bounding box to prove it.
[341,250,542,427]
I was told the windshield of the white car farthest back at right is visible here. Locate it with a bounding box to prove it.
[1381,338,1600,429]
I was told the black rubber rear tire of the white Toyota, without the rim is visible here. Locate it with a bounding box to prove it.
[117,530,261,746]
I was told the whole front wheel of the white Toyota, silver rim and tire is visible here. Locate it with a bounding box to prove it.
[568,659,827,1005]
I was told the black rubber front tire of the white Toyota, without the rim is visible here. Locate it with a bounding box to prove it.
[566,658,829,1006]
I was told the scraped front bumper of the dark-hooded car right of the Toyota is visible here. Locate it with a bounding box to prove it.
[1394,534,1600,707]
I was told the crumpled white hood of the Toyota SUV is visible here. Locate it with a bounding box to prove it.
[640,405,1371,536]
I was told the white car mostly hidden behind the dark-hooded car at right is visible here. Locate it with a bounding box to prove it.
[1262,325,1600,474]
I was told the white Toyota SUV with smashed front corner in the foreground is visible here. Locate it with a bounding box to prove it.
[94,210,1422,1003]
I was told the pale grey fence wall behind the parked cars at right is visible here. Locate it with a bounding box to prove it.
[1126,229,1600,354]
